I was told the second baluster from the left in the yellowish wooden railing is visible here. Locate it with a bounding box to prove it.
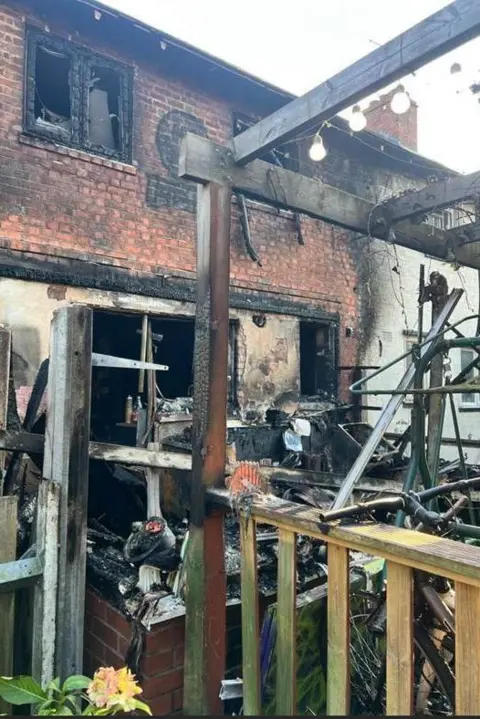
[277,529,297,716]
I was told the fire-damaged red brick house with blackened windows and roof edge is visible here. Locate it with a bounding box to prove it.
[0,0,454,714]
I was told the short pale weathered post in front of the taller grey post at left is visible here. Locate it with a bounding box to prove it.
[32,481,60,685]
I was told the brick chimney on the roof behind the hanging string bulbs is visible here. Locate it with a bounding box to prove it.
[364,89,418,152]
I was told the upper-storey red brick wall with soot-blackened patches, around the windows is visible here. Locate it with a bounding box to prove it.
[0,7,359,376]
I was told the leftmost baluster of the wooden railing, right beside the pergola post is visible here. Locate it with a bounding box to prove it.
[240,517,262,716]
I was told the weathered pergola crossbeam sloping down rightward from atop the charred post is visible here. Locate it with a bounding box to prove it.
[179,133,480,269]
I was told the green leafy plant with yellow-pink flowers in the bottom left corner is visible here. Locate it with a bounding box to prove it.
[0,667,152,716]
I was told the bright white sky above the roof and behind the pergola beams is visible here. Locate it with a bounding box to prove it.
[103,0,480,172]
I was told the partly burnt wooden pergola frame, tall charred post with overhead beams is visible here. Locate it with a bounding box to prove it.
[179,0,480,716]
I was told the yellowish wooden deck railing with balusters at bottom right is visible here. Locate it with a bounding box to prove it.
[237,498,480,716]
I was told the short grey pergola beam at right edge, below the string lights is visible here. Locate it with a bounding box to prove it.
[371,170,480,226]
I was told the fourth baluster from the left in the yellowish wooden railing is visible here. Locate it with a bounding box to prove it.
[387,562,413,716]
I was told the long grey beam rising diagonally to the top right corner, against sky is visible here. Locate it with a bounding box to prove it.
[233,0,480,164]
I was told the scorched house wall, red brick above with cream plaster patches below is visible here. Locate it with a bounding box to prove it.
[0,3,359,414]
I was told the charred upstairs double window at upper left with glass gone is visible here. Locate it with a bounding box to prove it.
[24,28,133,163]
